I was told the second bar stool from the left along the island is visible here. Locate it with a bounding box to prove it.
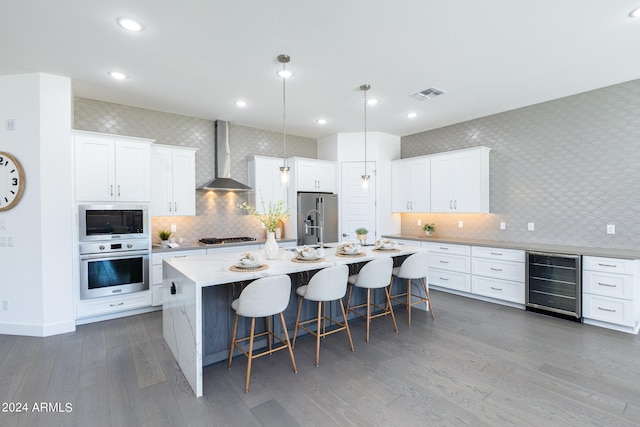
[292,265,354,366]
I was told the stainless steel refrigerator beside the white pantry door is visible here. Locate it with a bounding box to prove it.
[298,193,338,245]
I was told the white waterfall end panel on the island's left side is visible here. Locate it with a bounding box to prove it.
[162,261,202,397]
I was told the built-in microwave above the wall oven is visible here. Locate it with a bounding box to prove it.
[78,205,149,242]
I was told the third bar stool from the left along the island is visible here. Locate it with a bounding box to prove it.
[347,257,398,342]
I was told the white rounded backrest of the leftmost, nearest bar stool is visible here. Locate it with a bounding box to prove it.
[236,275,291,317]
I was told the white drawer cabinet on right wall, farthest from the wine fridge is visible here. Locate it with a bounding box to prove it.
[422,242,471,293]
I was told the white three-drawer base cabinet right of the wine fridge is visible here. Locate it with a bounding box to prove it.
[582,256,640,334]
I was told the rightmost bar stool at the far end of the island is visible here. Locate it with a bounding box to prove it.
[389,251,435,326]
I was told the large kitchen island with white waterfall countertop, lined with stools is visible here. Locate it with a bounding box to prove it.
[162,245,423,397]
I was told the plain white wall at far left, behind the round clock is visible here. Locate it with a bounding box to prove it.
[0,74,75,336]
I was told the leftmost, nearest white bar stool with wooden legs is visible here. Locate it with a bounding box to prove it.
[229,275,298,393]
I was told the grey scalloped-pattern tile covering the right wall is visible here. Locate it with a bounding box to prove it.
[401,80,640,249]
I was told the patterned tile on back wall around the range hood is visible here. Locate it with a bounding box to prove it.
[73,98,317,242]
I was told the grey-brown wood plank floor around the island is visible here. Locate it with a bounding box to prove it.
[0,291,640,427]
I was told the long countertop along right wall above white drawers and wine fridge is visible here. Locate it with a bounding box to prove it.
[382,234,640,259]
